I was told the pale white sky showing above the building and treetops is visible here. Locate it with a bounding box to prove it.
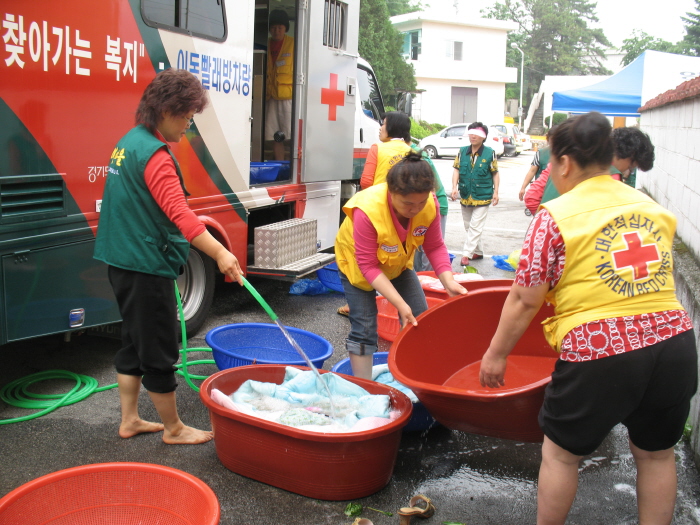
[432,0,695,47]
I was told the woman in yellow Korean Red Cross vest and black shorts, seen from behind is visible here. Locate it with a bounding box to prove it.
[480,113,697,524]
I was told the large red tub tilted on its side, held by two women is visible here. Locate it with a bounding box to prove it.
[389,287,558,442]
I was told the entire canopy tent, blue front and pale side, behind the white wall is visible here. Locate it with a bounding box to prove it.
[552,51,700,117]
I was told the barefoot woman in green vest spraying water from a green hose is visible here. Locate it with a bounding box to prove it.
[94,69,242,444]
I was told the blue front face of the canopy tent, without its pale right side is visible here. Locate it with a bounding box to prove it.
[552,53,645,117]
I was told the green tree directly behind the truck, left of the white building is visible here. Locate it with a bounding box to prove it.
[359,0,416,97]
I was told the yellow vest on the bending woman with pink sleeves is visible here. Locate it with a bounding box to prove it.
[335,183,437,291]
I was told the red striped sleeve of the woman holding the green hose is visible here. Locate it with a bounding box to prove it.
[143,149,206,242]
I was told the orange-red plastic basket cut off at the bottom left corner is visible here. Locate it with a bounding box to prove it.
[0,463,220,525]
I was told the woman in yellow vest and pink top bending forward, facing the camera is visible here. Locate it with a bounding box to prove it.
[335,152,467,379]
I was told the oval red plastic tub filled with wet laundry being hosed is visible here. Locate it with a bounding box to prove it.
[199,365,412,501]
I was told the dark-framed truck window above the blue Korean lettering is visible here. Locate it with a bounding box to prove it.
[141,0,226,41]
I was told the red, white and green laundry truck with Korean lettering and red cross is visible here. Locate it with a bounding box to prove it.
[0,0,384,344]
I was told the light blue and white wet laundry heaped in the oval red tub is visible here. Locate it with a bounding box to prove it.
[223,367,391,432]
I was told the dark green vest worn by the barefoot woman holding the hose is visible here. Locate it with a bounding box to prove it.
[94,126,190,279]
